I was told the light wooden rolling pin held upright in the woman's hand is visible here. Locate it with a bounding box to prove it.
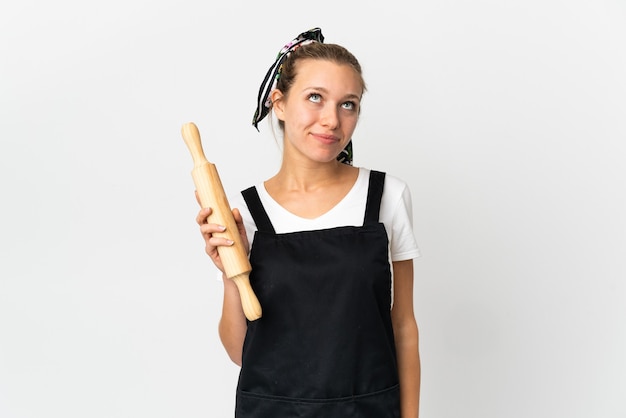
[182,122,261,321]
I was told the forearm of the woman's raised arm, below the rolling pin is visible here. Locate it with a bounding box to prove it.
[219,278,247,366]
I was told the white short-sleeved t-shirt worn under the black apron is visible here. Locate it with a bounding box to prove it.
[229,168,419,261]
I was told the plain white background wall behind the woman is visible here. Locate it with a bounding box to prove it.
[0,0,626,418]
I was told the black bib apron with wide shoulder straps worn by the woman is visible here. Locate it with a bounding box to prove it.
[235,171,400,418]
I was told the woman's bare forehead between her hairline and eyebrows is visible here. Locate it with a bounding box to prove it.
[294,58,363,96]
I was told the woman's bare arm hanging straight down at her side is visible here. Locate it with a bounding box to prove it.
[391,260,421,418]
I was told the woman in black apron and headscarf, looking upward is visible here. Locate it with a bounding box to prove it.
[197,28,420,418]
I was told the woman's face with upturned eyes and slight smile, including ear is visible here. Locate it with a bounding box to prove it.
[272,59,363,166]
